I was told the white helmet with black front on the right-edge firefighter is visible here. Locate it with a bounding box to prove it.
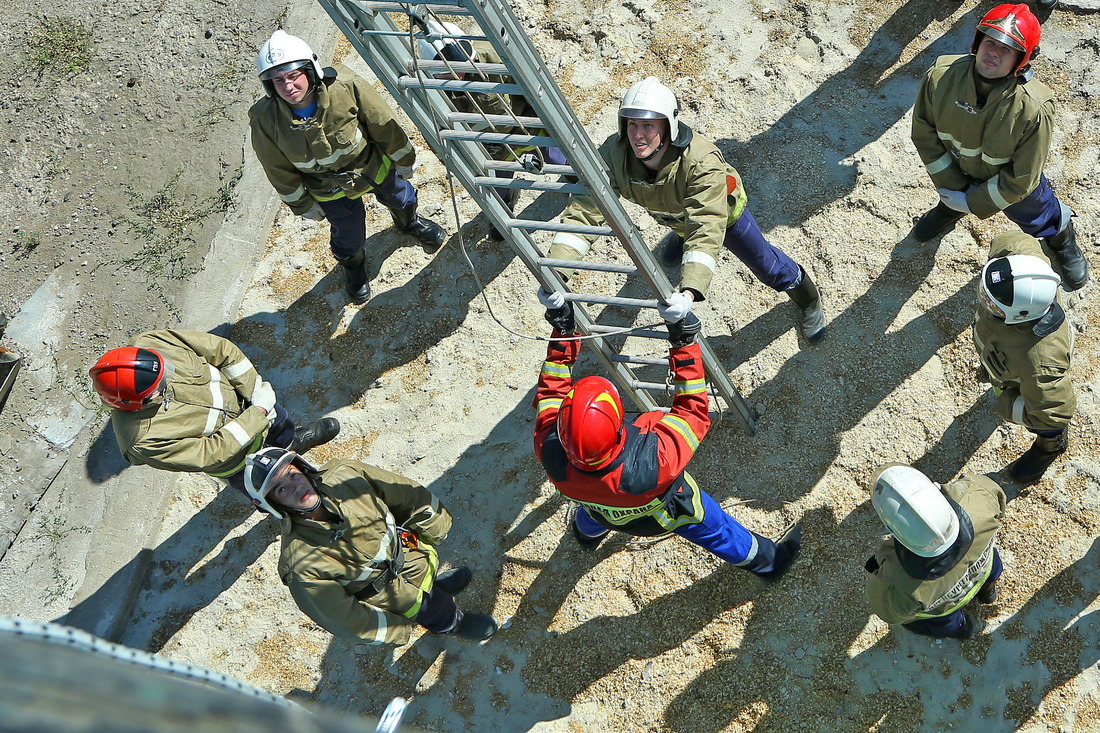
[978,254,1062,324]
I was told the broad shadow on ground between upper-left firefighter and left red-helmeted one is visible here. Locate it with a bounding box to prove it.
[231,214,516,413]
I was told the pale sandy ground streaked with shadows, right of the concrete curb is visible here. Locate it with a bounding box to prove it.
[19,0,1100,733]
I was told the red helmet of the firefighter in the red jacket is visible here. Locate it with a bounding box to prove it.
[558,376,624,471]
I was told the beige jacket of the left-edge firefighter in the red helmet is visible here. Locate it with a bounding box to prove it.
[111,330,268,475]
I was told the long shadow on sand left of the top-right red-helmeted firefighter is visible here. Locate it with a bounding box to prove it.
[701,0,982,231]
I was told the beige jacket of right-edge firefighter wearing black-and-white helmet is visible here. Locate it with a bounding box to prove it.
[971,232,1077,430]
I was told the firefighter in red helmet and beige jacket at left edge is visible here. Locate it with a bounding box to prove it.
[89,330,340,479]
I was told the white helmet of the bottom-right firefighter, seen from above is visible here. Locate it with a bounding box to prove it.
[871,463,959,557]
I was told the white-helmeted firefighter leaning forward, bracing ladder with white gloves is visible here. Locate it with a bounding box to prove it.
[550,76,825,343]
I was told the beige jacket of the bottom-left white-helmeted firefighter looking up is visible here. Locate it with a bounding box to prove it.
[278,459,451,644]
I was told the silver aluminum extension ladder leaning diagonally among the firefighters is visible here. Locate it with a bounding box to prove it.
[318,0,756,435]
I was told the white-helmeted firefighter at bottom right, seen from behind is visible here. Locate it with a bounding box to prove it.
[865,463,1005,638]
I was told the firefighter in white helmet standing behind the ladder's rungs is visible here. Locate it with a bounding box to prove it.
[417,21,569,241]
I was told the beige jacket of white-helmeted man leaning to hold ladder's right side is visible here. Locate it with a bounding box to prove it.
[550,129,748,300]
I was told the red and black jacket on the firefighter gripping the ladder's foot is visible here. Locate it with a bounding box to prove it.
[535,331,711,536]
